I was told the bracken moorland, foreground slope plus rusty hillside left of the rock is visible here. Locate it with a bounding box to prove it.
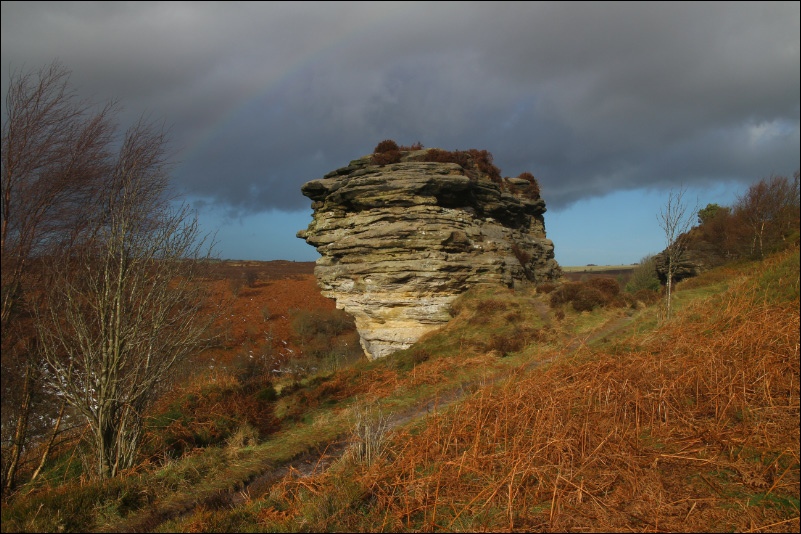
[2,246,799,532]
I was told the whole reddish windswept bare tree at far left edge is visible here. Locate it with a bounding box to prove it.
[0,62,115,491]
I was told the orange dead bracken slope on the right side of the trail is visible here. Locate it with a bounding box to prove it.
[202,251,799,531]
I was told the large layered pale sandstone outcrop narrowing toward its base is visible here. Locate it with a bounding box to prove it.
[298,150,561,358]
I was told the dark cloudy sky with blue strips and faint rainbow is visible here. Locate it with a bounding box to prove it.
[0,1,801,266]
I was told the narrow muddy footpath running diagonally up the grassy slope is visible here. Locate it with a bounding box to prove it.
[103,316,634,532]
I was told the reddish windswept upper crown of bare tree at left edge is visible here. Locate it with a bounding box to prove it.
[0,62,115,326]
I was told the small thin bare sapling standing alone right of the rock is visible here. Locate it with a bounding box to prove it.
[656,186,698,319]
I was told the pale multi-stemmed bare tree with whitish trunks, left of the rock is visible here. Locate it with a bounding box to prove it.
[37,122,216,477]
